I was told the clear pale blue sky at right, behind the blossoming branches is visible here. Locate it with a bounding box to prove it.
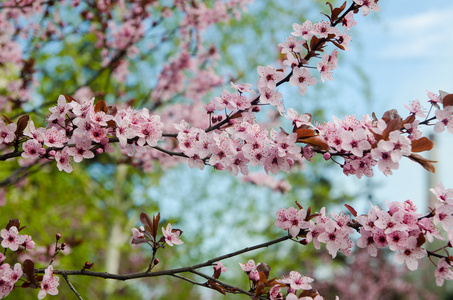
[334,0,453,210]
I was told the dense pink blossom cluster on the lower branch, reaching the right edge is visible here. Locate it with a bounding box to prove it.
[275,184,453,285]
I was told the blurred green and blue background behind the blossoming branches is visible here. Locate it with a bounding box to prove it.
[0,0,453,299]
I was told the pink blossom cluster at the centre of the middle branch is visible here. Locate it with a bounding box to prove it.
[175,120,302,175]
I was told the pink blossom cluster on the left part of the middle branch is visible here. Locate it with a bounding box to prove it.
[16,95,163,173]
